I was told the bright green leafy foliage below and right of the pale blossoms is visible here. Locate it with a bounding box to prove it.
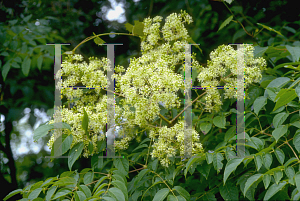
[2,1,300,201]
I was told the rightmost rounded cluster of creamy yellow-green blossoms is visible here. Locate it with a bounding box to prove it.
[197,44,267,112]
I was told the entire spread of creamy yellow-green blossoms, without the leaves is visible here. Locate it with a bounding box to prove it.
[48,11,265,167]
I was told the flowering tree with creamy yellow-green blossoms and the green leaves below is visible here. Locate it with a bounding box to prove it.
[7,5,300,201]
